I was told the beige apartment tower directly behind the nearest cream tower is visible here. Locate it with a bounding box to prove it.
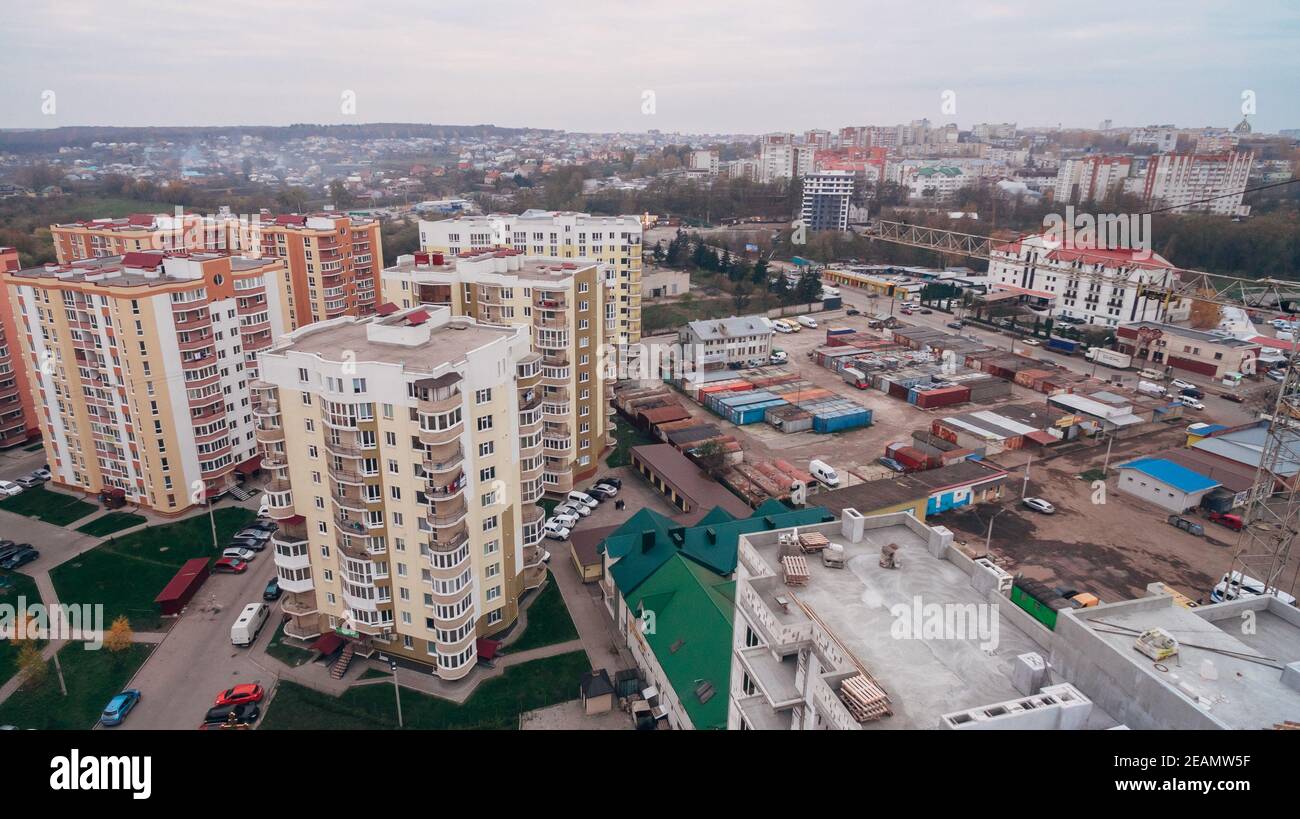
[382,250,620,493]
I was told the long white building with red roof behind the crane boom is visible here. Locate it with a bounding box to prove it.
[988,235,1187,328]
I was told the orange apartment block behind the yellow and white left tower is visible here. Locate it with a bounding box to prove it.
[49,211,384,329]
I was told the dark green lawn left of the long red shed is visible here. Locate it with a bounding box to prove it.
[51,504,253,631]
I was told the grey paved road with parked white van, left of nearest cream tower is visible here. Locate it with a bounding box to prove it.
[114,549,281,731]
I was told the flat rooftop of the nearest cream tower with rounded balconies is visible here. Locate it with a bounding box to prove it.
[273,306,517,373]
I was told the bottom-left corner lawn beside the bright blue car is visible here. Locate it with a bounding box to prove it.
[0,642,152,731]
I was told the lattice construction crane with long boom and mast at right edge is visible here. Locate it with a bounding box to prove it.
[861,220,1300,599]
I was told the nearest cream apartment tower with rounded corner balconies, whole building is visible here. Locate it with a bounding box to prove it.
[254,306,546,680]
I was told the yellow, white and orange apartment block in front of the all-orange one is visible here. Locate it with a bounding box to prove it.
[0,251,289,515]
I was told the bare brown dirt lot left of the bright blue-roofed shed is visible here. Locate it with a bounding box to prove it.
[927,428,1238,601]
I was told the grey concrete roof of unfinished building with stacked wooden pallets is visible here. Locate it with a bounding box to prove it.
[741,514,1081,731]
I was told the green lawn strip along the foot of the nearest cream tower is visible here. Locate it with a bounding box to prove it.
[263,651,592,731]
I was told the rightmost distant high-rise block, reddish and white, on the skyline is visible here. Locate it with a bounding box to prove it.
[1143,151,1255,216]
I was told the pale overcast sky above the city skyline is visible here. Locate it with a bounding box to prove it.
[0,0,1300,134]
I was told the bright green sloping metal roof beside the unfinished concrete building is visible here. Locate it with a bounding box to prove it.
[627,554,736,729]
